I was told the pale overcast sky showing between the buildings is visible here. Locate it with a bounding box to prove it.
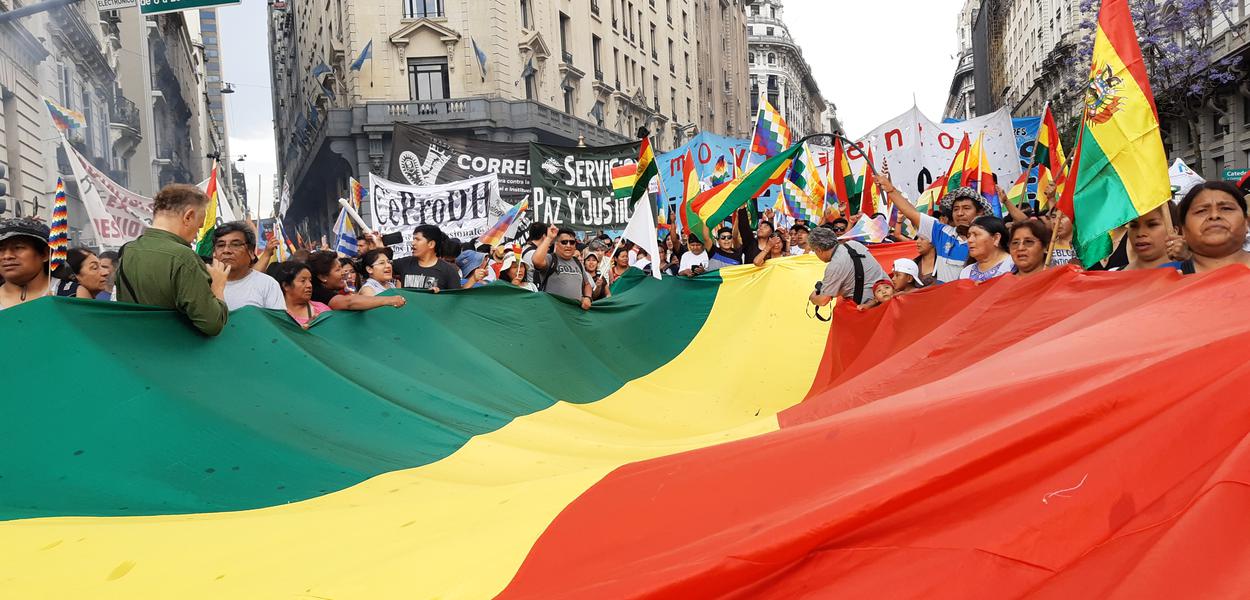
[218,0,963,215]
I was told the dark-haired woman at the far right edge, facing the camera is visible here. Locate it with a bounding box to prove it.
[1169,181,1250,275]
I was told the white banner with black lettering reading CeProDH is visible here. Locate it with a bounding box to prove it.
[369,173,503,258]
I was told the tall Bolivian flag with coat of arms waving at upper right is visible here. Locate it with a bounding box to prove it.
[1059,0,1171,266]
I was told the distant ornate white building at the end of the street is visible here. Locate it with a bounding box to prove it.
[746,0,828,139]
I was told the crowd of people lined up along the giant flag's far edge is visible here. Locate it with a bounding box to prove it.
[0,178,1250,335]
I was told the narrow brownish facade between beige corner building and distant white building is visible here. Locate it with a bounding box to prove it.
[694,0,753,138]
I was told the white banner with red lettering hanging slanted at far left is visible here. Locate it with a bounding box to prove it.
[61,139,153,248]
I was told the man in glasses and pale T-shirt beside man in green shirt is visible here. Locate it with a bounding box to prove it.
[213,221,286,310]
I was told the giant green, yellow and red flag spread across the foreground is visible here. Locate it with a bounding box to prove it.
[7,245,1250,600]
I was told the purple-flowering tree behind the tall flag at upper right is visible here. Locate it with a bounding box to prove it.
[1051,0,1241,170]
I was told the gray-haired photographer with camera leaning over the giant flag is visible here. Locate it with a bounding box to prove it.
[808,226,889,306]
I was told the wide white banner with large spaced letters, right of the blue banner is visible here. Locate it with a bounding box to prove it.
[816,108,1020,201]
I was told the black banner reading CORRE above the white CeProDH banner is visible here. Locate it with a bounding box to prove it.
[388,123,530,206]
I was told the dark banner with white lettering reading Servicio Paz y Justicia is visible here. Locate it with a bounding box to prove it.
[530,141,639,231]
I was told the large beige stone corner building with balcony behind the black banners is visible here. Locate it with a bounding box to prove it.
[270,0,721,229]
